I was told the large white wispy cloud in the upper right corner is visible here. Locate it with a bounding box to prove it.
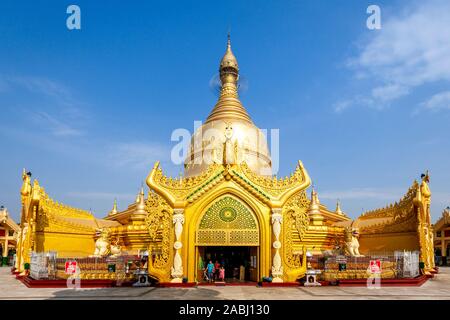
[334,0,450,112]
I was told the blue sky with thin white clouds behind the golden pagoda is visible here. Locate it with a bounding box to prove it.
[0,0,450,220]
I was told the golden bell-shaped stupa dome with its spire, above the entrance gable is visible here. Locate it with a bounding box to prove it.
[184,36,272,177]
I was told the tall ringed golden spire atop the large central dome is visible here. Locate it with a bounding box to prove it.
[206,33,252,123]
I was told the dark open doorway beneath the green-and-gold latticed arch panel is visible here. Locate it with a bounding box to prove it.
[197,246,258,283]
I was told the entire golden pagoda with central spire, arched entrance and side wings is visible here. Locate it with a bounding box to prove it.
[16,38,434,283]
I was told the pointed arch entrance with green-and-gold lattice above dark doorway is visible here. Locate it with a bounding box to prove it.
[195,194,261,281]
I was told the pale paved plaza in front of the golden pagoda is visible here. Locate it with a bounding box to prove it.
[0,268,450,300]
